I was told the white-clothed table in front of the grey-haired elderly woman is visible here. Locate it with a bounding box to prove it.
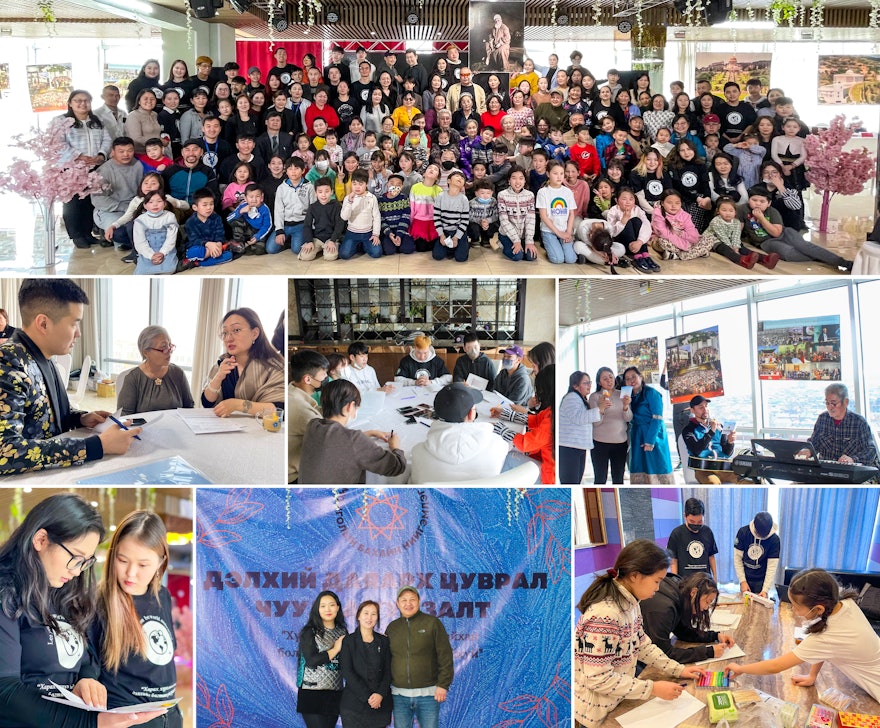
[11,410,287,485]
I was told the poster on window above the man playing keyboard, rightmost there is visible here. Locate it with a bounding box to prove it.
[758,316,840,382]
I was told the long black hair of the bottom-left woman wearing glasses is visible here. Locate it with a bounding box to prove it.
[0,493,105,633]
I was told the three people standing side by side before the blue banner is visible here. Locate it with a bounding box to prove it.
[296,586,454,728]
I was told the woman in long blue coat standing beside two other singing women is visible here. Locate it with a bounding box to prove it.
[623,367,675,484]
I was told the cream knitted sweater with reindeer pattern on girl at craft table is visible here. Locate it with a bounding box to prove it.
[574,581,684,728]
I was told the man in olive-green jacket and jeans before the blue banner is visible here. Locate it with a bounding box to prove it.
[385,586,454,728]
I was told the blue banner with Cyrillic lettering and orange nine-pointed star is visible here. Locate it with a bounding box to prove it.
[196,488,571,728]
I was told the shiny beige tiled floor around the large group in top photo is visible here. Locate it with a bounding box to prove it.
[0,188,874,277]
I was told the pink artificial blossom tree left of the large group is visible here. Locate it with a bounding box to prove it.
[0,116,103,265]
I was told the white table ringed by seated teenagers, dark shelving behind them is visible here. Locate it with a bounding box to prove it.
[351,385,525,485]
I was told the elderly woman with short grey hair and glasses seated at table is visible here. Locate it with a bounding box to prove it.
[116,326,195,415]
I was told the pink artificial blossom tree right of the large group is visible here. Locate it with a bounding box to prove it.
[804,114,876,233]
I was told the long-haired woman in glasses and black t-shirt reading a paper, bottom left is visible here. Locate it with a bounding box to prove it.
[0,493,164,728]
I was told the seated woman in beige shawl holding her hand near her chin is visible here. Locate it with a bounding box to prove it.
[202,308,284,417]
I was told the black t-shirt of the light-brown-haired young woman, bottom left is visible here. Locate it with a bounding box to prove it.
[90,587,177,708]
